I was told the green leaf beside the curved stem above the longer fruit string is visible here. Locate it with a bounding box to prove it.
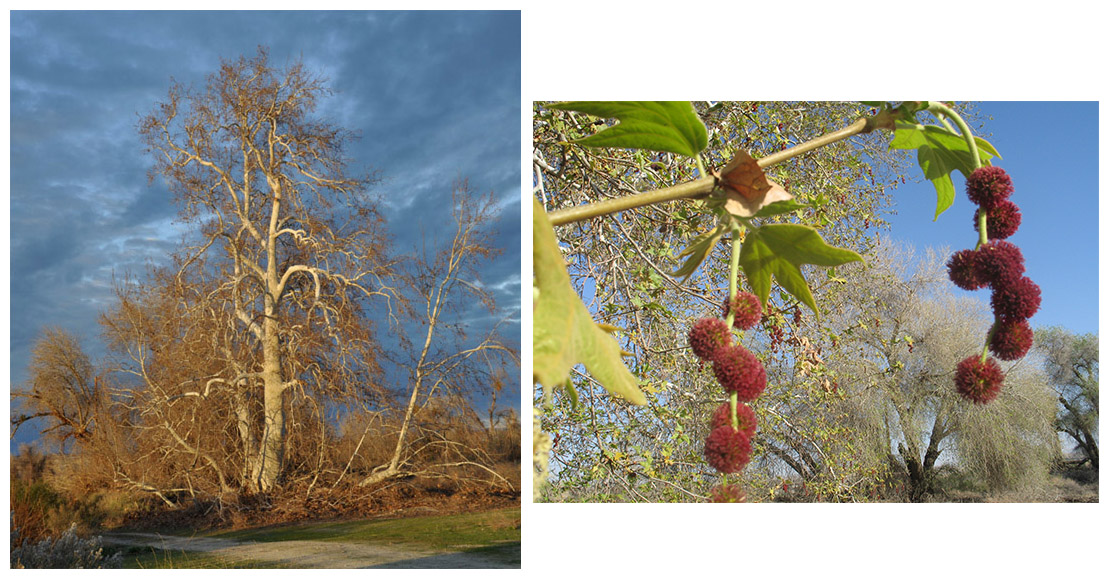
[890,124,995,221]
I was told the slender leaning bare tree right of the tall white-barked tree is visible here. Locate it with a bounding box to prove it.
[361,183,517,486]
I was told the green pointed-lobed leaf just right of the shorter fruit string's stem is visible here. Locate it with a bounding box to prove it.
[739,224,862,314]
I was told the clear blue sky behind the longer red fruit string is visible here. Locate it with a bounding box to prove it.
[890,102,1100,334]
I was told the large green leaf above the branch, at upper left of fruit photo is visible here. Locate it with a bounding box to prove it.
[548,101,708,158]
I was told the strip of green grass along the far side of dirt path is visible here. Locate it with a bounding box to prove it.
[209,508,521,557]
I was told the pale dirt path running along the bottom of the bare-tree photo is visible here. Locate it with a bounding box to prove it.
[102,533,510,569]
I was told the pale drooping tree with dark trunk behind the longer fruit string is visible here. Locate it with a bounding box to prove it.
[822,244,1056,502]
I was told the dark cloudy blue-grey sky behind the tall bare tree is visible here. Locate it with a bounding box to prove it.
[9,11,521,447]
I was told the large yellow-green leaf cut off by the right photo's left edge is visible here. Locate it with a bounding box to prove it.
[533,200,646,404]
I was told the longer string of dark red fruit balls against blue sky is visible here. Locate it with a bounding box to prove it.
[946,166,1042,403]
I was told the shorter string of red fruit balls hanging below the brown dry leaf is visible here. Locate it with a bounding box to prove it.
[689,292,766,483]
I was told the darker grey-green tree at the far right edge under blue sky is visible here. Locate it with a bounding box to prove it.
[1035,327,1101,470]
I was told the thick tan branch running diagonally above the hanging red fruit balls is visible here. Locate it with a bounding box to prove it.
[549,116,893,227]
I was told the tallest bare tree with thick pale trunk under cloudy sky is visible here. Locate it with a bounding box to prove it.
[139,48,393,492]
